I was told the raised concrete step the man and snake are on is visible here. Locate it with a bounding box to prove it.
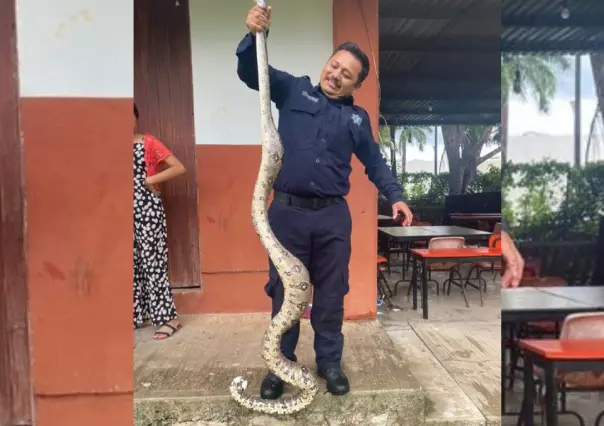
[134,314,430,426]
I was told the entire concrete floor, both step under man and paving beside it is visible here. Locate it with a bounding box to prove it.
[135,262,604,426]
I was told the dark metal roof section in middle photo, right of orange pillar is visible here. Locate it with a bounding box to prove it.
[380,0,500,125]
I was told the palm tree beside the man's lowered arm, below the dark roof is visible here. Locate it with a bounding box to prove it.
[380,126,430,176]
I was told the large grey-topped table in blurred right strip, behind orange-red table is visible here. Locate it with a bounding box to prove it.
[501,286,604,416]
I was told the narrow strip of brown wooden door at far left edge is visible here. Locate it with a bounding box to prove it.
[0,0,33,426]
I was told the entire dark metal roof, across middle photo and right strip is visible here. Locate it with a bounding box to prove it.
[380,0,604,125]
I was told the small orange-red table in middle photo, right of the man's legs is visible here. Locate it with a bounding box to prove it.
[409,247,501,319]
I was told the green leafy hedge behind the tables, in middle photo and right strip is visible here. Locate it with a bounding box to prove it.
[399,160,604,241]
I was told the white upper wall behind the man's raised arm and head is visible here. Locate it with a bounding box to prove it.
[190,0,333,145]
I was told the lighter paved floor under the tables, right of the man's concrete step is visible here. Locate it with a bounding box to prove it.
[379,264,501,426]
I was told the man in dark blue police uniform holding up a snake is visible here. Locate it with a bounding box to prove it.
[237,6,412,399]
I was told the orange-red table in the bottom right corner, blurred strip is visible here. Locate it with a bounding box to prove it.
[519,339,604,426]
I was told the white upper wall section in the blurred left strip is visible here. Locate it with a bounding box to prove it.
[17,0,134,98]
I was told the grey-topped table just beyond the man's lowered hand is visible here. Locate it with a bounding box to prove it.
[378,226,492,288]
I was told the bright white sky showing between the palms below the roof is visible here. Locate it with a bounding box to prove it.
[407,56,597,161]
